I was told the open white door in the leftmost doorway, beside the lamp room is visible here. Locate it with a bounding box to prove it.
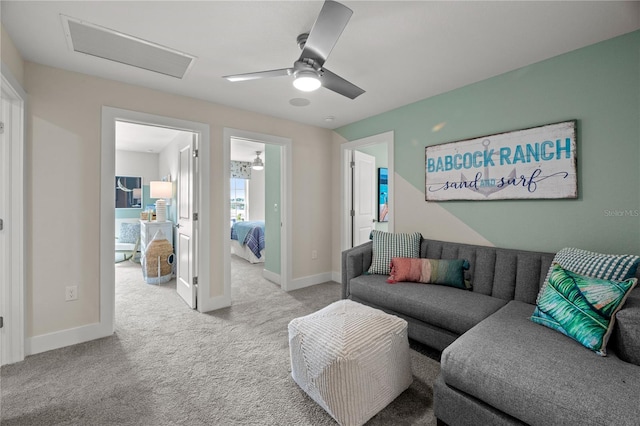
[176,133,198,309]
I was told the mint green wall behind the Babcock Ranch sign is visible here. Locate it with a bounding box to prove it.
[336,31,640,254]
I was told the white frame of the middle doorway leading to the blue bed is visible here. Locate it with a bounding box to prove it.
[221,127,293,302]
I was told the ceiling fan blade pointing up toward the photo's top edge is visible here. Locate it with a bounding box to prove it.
[300,0,353,66]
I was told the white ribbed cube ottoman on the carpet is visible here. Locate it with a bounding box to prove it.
[289,300,413,426]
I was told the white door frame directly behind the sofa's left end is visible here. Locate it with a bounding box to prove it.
[340,131,395,250]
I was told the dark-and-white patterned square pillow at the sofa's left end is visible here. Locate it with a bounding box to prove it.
[368,230,422,275]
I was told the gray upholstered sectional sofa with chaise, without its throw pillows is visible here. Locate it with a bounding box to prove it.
[342,239,640,426]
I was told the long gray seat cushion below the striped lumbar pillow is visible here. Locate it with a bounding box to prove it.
[350,275,507,334]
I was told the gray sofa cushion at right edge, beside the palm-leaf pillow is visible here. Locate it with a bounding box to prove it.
[609,287,640,365]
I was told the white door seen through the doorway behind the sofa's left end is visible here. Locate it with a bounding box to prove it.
[352,151,376,247]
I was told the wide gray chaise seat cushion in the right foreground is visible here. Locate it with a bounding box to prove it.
[441,301,640,425]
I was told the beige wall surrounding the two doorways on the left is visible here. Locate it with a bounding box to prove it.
[25,61,333,337]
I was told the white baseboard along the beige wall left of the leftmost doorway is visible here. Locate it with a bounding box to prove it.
[24,323,113,355]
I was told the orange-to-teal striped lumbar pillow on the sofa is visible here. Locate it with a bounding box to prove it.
[387,257,469,289]
